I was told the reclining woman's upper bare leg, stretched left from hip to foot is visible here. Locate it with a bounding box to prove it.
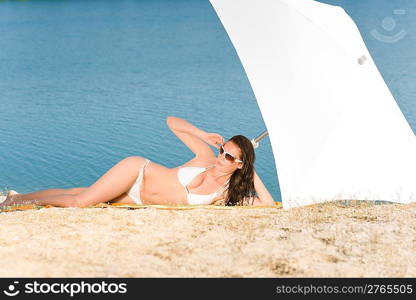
[5,156,145,207]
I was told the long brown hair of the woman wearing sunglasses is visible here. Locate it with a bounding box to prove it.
[225,135,256,206]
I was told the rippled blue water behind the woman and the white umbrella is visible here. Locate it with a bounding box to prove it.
[0,0,416,201]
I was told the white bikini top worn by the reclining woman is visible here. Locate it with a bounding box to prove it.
[178,165,228,205]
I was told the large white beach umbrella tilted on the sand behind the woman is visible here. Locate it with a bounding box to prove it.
[210,0,416,208]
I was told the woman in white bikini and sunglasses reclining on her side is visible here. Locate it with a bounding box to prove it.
[1,117,274,207]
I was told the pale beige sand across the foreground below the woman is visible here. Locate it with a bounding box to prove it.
[0,197,416,277]
